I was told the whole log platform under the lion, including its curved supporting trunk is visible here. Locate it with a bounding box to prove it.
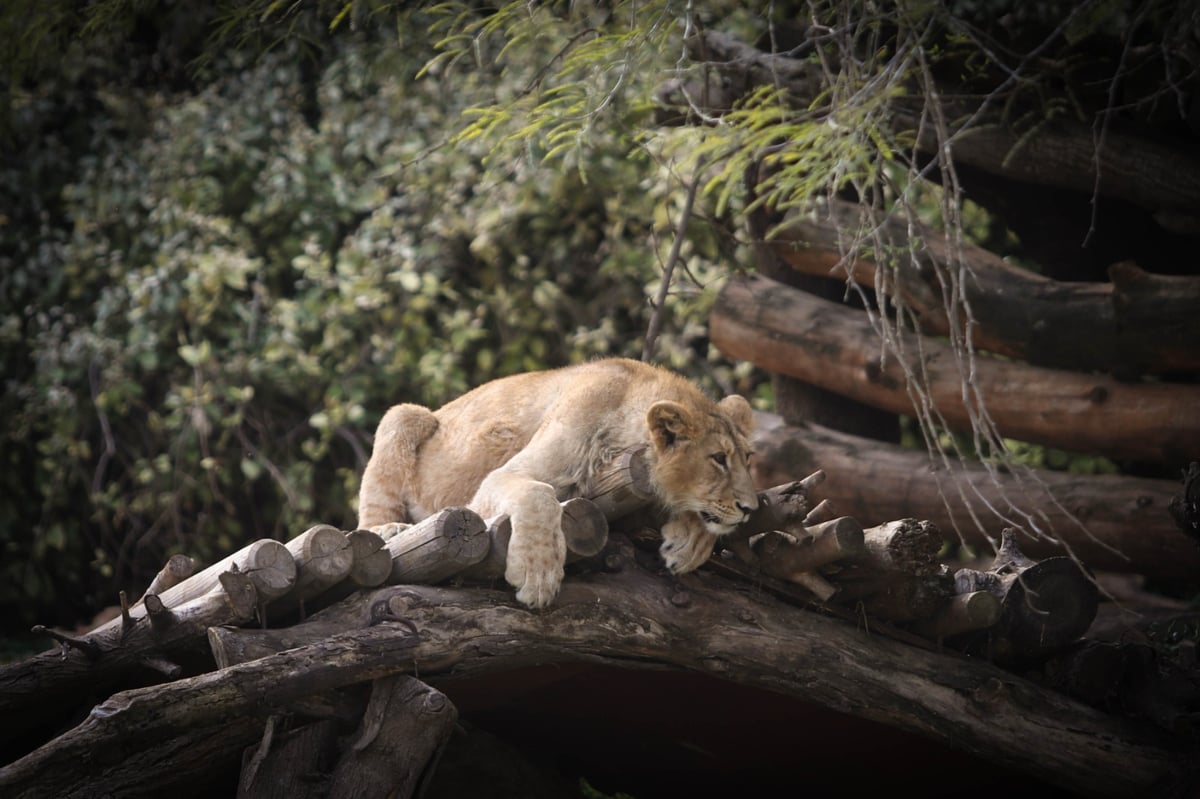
[0,451,1189,798]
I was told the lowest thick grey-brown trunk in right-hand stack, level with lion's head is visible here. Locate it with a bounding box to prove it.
[754,414,1200,579]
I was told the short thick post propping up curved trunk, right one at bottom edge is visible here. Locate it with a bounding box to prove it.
[329,674,458,799]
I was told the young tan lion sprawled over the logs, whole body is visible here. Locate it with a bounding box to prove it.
[359,359,757,607]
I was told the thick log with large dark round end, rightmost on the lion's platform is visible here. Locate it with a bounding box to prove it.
[954,529,1099,666]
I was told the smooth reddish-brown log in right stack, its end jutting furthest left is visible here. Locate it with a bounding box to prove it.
[710,275,1200,464]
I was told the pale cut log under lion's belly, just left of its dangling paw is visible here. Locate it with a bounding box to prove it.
[384,507,490,583]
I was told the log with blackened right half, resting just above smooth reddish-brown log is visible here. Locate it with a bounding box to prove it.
[767,200,1200,378]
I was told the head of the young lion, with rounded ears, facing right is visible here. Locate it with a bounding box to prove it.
[646,395,758,535]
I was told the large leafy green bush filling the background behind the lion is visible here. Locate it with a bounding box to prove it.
[0,24,736,630]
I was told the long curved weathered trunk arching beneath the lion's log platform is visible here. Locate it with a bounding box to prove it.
[0,535,1188,797]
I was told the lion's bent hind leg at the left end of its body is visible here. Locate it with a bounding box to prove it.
[359,404,438,531]
